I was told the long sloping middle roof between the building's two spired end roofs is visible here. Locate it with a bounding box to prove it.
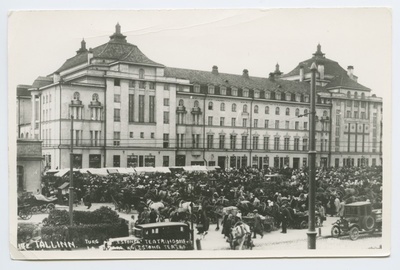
[164,67,325,94]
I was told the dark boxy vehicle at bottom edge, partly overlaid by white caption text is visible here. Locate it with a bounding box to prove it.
[102,222,194,250]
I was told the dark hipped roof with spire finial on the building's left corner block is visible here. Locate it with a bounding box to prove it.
[56,24,163,72]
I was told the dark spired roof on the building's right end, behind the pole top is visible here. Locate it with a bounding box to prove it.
[281,44,371,91]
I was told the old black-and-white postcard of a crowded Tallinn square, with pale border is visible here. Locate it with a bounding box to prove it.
[8,8,392,260]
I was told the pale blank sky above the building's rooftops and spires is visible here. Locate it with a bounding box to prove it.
[8,8,391,96]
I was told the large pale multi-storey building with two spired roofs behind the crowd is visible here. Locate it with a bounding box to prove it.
[17,25,382,169]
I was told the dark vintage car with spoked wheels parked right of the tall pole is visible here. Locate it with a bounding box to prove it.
[331,201,382,240]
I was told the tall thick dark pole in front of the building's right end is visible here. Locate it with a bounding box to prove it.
[307,62,317,249]
